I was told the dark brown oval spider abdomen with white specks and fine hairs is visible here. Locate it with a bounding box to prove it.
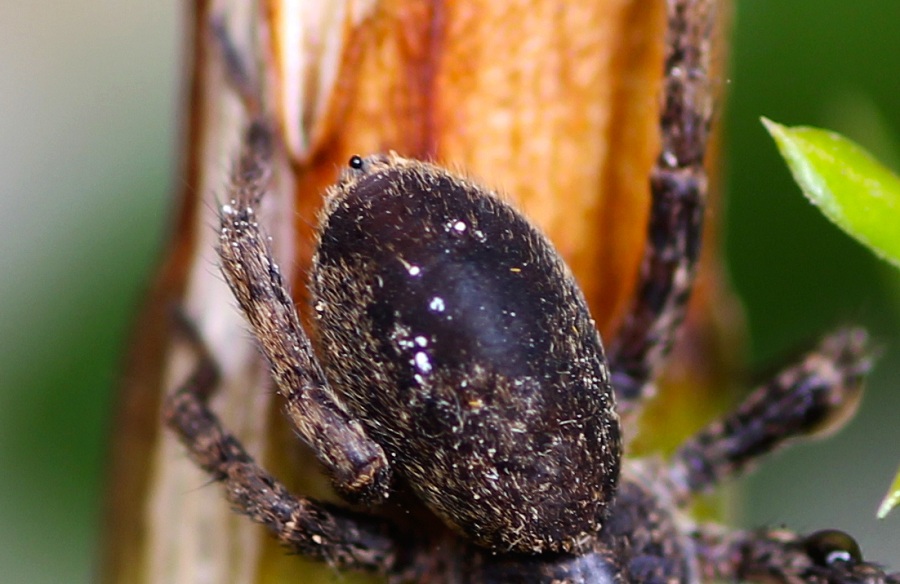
[311,156,621,552]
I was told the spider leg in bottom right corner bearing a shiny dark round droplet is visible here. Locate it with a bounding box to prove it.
[694,525,900,584]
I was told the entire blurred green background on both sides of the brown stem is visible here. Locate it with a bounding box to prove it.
[0,0,900,583]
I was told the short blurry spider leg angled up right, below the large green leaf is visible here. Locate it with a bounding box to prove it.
[669,329,872,500]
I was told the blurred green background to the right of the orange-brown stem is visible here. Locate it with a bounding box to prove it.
[725,0,900,570]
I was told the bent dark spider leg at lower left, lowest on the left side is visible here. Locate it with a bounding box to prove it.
[163,308,408,574]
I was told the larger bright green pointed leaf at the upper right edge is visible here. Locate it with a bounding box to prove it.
[762,118,900,268]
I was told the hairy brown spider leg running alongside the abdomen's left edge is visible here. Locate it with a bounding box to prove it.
[219,122,390,503]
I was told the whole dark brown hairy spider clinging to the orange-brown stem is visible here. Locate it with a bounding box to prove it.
[165,0,900,584]
